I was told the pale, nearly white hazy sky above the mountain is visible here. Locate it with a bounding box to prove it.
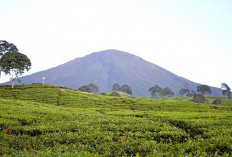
[0,0,232,87]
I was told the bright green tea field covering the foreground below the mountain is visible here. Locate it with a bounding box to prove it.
[0,84,232,157]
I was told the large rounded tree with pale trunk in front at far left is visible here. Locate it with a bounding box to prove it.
[0,51,31,88]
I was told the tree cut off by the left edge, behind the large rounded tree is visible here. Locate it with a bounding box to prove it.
[0,40,18,78]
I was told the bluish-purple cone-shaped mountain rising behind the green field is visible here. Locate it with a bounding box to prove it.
[6,50,221,96]
